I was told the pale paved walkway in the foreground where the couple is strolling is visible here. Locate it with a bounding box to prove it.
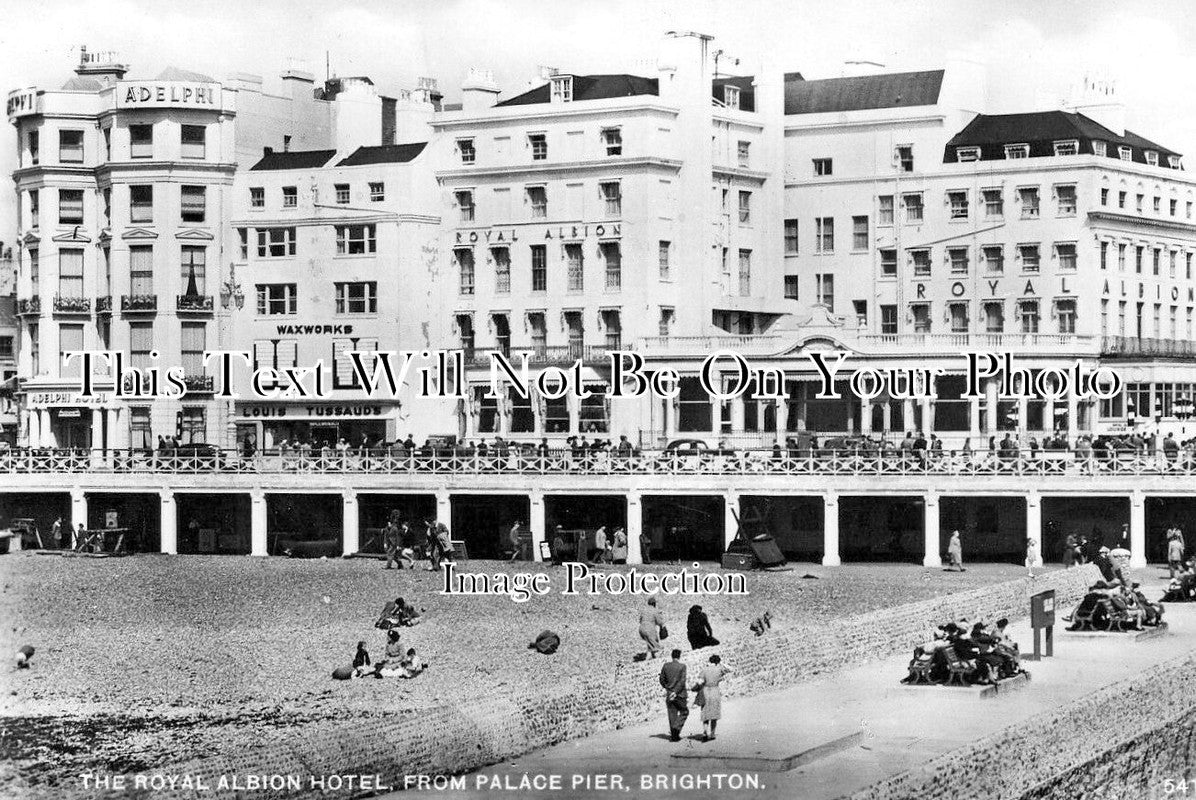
[385,566,1196,800]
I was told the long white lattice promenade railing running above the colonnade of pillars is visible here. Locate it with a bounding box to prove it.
[0,446,1196,483]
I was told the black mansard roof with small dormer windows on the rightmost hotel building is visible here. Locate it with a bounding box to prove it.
[942,111,1179,166]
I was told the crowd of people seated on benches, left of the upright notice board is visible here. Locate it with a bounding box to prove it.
[903,618,1025,684]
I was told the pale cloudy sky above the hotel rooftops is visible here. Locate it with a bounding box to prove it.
[0,0,1196,242]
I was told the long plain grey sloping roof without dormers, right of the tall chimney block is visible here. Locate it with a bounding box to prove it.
[785,69,942,114]
